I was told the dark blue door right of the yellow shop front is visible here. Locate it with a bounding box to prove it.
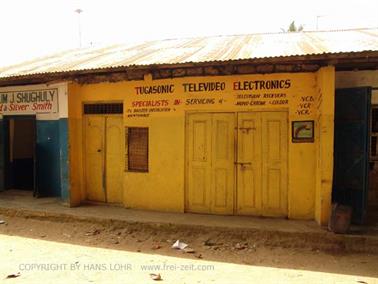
[332,87,371,224]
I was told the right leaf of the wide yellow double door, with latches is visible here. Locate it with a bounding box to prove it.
[236,112,288,216]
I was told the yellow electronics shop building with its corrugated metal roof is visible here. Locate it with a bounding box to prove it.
[0,30,378,225]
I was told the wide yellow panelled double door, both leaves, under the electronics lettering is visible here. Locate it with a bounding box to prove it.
[186,112,288,216]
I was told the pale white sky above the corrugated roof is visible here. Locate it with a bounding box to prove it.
[0,0,378,66]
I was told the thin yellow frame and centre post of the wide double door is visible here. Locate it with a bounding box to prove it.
[183,108,291,216]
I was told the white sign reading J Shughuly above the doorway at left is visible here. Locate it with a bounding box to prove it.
[0,88,58,114]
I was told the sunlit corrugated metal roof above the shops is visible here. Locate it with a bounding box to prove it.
[0,28,378,78]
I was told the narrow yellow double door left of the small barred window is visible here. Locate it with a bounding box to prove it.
[84,115,125,203]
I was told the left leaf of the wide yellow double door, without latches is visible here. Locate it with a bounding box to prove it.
[186,113,234,214]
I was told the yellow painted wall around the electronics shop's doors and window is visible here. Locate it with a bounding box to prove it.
[69,69,334,219]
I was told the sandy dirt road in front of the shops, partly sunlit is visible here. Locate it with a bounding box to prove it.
[0,216,378,284]
